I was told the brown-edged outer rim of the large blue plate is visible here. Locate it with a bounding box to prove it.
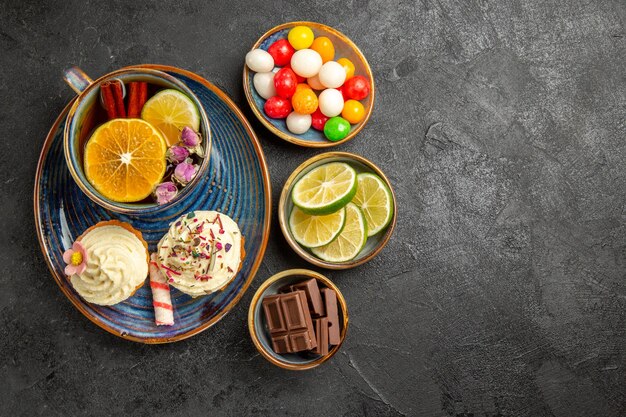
[33,64,272,344]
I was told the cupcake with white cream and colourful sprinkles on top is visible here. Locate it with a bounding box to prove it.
[158,211,245,297]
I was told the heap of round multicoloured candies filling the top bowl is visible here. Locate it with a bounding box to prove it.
[246,26,371,141]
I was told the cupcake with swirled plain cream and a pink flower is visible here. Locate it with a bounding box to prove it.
[63,220,150,305]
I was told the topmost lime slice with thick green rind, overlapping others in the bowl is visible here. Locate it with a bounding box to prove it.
[291,162,356,216]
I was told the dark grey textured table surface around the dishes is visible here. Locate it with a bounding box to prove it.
[0,0,626,417]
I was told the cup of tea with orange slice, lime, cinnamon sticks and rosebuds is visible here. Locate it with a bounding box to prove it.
[63,67,211,215]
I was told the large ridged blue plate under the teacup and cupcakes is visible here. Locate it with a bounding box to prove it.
[34,65,271,343]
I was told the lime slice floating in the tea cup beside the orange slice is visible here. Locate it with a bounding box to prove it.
[141,90,200,146]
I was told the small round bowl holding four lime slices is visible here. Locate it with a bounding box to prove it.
[278,152,397,269]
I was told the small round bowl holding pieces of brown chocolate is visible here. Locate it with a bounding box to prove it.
[248,269,348,371]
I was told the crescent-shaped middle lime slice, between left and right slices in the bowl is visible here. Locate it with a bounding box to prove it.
[311,203,367,263]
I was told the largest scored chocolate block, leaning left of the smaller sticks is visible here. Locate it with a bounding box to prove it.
[263,291,317,353]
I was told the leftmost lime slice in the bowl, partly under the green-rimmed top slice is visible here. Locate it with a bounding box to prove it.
[289,206,346,248]
